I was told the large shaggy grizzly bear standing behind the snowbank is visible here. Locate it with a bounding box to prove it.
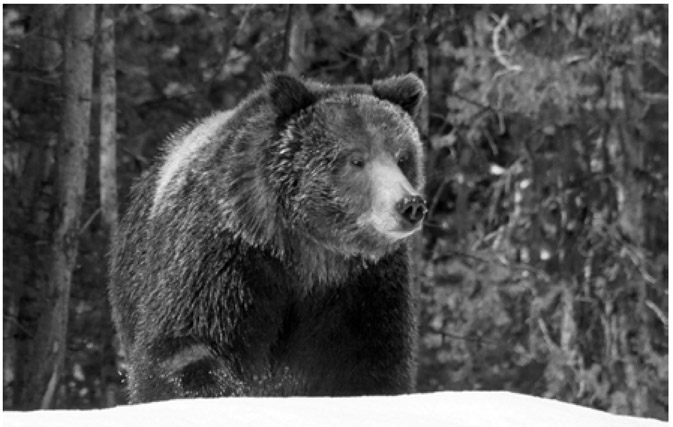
[109,74,426,403]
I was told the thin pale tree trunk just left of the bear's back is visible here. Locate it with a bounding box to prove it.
[99,4,118,238]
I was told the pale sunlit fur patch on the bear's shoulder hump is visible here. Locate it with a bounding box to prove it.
[150,110,234,217]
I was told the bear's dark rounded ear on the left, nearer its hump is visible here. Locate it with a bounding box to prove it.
[267,73,316,120]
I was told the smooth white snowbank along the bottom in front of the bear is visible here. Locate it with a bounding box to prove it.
[2,392,667,427]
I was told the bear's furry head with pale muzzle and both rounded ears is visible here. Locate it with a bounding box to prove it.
[267,74,426,259]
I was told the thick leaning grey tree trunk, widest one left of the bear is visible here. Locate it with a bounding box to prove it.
[24,5,95,409]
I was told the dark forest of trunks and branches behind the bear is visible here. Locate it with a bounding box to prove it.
[3,5,668,419]
